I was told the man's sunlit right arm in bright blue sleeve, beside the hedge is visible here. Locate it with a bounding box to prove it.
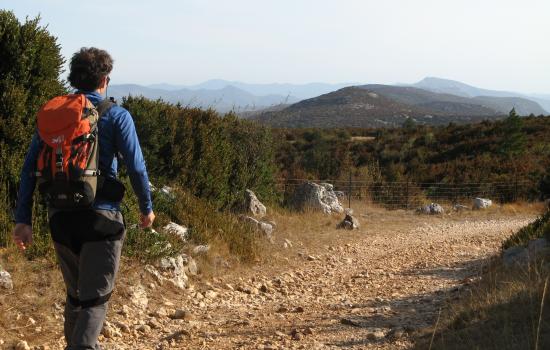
[115,110,155,227]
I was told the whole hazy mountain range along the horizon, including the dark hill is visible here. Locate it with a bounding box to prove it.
[108,78,550,121]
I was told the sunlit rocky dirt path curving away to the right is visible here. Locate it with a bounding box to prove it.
[96,215,534,349]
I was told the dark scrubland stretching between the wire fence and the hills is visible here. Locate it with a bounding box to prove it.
[275,111,550,202]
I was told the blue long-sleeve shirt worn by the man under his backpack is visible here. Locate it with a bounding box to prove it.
[15,92,153,225]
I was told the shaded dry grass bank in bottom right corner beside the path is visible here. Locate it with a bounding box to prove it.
[416,260,550,350]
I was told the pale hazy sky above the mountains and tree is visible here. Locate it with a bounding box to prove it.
[5,0,550,93]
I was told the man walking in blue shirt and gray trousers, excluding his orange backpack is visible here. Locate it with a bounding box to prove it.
[13,47,155,350]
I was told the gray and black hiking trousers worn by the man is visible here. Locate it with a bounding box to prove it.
[50,210,125,350]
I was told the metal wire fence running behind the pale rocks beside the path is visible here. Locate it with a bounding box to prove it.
[277,179,535,209]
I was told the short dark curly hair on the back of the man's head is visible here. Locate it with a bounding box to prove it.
[69,47,113,91]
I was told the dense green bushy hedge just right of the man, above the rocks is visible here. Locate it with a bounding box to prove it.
[122,97,276,209]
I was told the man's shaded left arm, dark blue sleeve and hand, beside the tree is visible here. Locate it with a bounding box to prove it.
[13,133,40,250]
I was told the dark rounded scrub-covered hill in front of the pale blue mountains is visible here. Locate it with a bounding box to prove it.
[252,85,503,128]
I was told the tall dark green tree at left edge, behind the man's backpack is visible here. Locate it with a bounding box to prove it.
[0,10,66,246]
